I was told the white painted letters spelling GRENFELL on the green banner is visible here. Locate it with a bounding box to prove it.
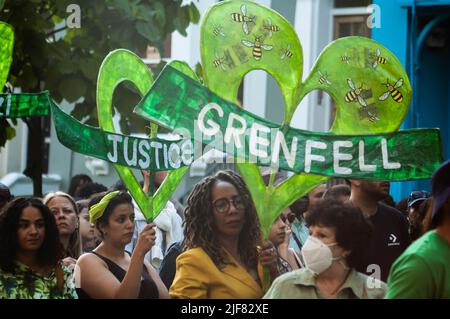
[196,103,401,175]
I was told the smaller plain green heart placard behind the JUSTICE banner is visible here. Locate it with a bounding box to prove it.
[97,49,190,222]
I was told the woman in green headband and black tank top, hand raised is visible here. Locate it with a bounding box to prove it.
[75,191,169,299]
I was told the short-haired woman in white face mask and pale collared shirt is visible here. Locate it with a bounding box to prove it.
[264,200,386,299]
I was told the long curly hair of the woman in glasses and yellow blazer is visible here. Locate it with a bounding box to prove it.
[183,170,261,269]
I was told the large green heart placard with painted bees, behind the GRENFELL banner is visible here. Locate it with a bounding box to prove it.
[200,1,411,238]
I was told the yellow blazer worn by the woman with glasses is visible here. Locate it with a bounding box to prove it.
[169,248,263,299]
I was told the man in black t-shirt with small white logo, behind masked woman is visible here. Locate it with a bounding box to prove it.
[350,180,411,282]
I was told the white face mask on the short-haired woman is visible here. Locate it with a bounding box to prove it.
[302,236,341,275]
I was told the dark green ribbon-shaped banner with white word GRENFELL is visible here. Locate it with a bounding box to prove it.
[134,66,442,181]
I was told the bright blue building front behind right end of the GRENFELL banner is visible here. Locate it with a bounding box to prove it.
[372,0,450,201]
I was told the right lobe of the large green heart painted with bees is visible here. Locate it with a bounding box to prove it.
[302,36,412,134]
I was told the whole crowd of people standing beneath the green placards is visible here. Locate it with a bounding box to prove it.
[0,161,450,299]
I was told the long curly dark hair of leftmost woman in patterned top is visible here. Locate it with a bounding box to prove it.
[0,197,63,273]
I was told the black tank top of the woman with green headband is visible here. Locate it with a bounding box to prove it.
[77,251,159,299]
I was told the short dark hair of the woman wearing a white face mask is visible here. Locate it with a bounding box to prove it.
[305,199,373,269]
